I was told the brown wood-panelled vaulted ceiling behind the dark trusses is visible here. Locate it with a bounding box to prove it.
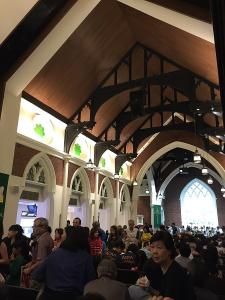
[20,0,218,149]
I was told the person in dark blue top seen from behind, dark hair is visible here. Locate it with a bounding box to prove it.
[32,226,95,300]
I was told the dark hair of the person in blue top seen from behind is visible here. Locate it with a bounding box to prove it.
[60,226,88,252]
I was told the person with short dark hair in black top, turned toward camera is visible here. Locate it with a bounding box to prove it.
[129,231,196,300]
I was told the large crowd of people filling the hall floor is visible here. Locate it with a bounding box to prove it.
[0,218,225,300]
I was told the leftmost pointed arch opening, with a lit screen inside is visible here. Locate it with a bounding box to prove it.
[16,152,58,236]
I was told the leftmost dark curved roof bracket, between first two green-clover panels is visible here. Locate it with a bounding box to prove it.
[64,121,95,153]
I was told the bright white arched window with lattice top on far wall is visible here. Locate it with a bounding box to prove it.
[180,178,218,227]
